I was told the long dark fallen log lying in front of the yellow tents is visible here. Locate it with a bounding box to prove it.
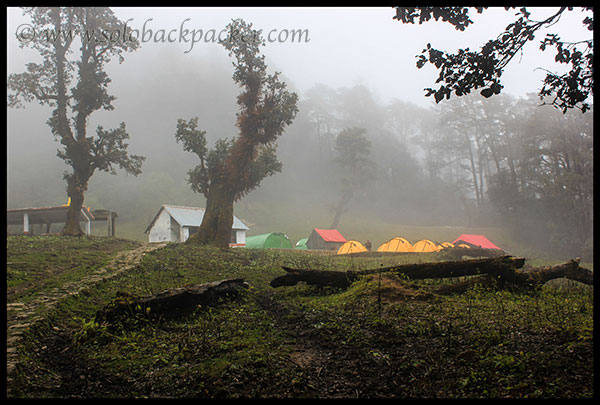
[271,256,525,288]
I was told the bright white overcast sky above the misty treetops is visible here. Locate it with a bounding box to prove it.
[7,7,590,107]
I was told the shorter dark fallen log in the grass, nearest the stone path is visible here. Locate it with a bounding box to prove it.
[96,279,248,323]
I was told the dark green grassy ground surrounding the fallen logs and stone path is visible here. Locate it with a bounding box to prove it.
[7,237,593,398]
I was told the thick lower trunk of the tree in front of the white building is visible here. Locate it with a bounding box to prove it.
[188,186,234,248]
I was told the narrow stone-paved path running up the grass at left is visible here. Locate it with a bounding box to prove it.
[6,243,166,375]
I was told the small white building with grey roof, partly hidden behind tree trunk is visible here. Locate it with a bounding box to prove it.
[146,204,249,247]
